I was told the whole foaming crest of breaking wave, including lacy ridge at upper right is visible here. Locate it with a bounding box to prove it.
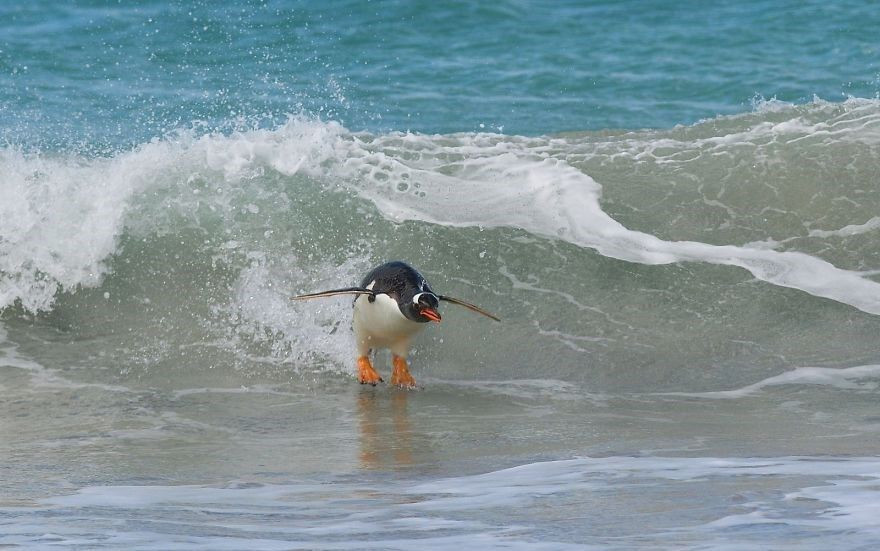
[0,100,880,314]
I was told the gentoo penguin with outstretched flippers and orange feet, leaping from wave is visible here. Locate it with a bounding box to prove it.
[292,261,501,388]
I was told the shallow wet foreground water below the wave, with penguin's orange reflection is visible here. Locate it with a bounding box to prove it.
[0,350,880,549]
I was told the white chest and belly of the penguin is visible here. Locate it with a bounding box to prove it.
[353,294,427,348]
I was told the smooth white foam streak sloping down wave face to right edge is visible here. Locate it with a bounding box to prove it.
[320,132,880,314]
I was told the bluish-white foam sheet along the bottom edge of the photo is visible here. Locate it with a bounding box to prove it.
[0,456,880,549]
